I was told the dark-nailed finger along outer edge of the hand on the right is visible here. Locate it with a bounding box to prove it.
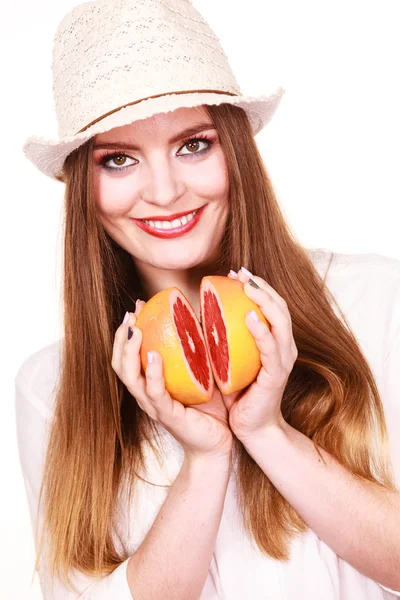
[244,283,294,360]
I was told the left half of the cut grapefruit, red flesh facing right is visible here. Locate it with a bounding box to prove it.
[136,287,214,404]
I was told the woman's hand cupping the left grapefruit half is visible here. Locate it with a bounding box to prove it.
[111,301,233,459]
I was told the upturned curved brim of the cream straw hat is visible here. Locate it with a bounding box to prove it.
[23,88,285,179]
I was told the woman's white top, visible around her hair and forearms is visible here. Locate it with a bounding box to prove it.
[16,249,400,600]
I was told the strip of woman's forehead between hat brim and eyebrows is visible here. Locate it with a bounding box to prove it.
[95,106,211,144]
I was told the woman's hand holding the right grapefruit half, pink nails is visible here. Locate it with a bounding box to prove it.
[223,268,298,444]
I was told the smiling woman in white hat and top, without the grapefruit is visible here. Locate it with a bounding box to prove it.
[16,0,400,600]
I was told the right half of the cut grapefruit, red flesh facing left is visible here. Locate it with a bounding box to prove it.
[200,275,269,394]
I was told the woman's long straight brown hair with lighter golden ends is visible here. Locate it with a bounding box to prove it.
[35,104,396,582]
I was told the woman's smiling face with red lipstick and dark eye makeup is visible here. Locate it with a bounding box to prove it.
[93,107,229,269]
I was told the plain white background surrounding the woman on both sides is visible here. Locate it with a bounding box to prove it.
[0,0,400,600]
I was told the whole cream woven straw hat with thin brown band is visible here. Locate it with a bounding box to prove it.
[23,0,284,179]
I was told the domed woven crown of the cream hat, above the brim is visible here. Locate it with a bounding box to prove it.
[52,0,241,138]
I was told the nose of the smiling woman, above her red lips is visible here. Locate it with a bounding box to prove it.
[141,154,185,206]
